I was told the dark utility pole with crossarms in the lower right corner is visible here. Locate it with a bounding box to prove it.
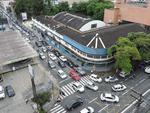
[131,89,144,113]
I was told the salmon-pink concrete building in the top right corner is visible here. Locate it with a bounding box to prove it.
[104,0,150,26]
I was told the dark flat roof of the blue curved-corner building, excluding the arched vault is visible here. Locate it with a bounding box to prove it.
[36,13,145,48]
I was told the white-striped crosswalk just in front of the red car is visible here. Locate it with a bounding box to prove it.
[60,76,92,99]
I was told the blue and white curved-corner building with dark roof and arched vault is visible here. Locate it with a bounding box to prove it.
[32,12,144,69]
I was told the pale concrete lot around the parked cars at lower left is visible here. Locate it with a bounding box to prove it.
[0,65,52,113]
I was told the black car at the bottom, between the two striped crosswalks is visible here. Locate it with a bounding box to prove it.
[66,98,84,111]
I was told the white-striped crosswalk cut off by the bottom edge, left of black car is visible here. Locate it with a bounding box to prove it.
[49,103,67,113]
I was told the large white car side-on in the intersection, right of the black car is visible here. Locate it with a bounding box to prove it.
[100,93,119,103]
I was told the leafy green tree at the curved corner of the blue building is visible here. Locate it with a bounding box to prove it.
[108,37,141,73]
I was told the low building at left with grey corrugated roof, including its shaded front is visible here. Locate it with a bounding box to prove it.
[0,31,38,74]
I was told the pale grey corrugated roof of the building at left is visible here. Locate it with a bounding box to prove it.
[0,31,37,66]
